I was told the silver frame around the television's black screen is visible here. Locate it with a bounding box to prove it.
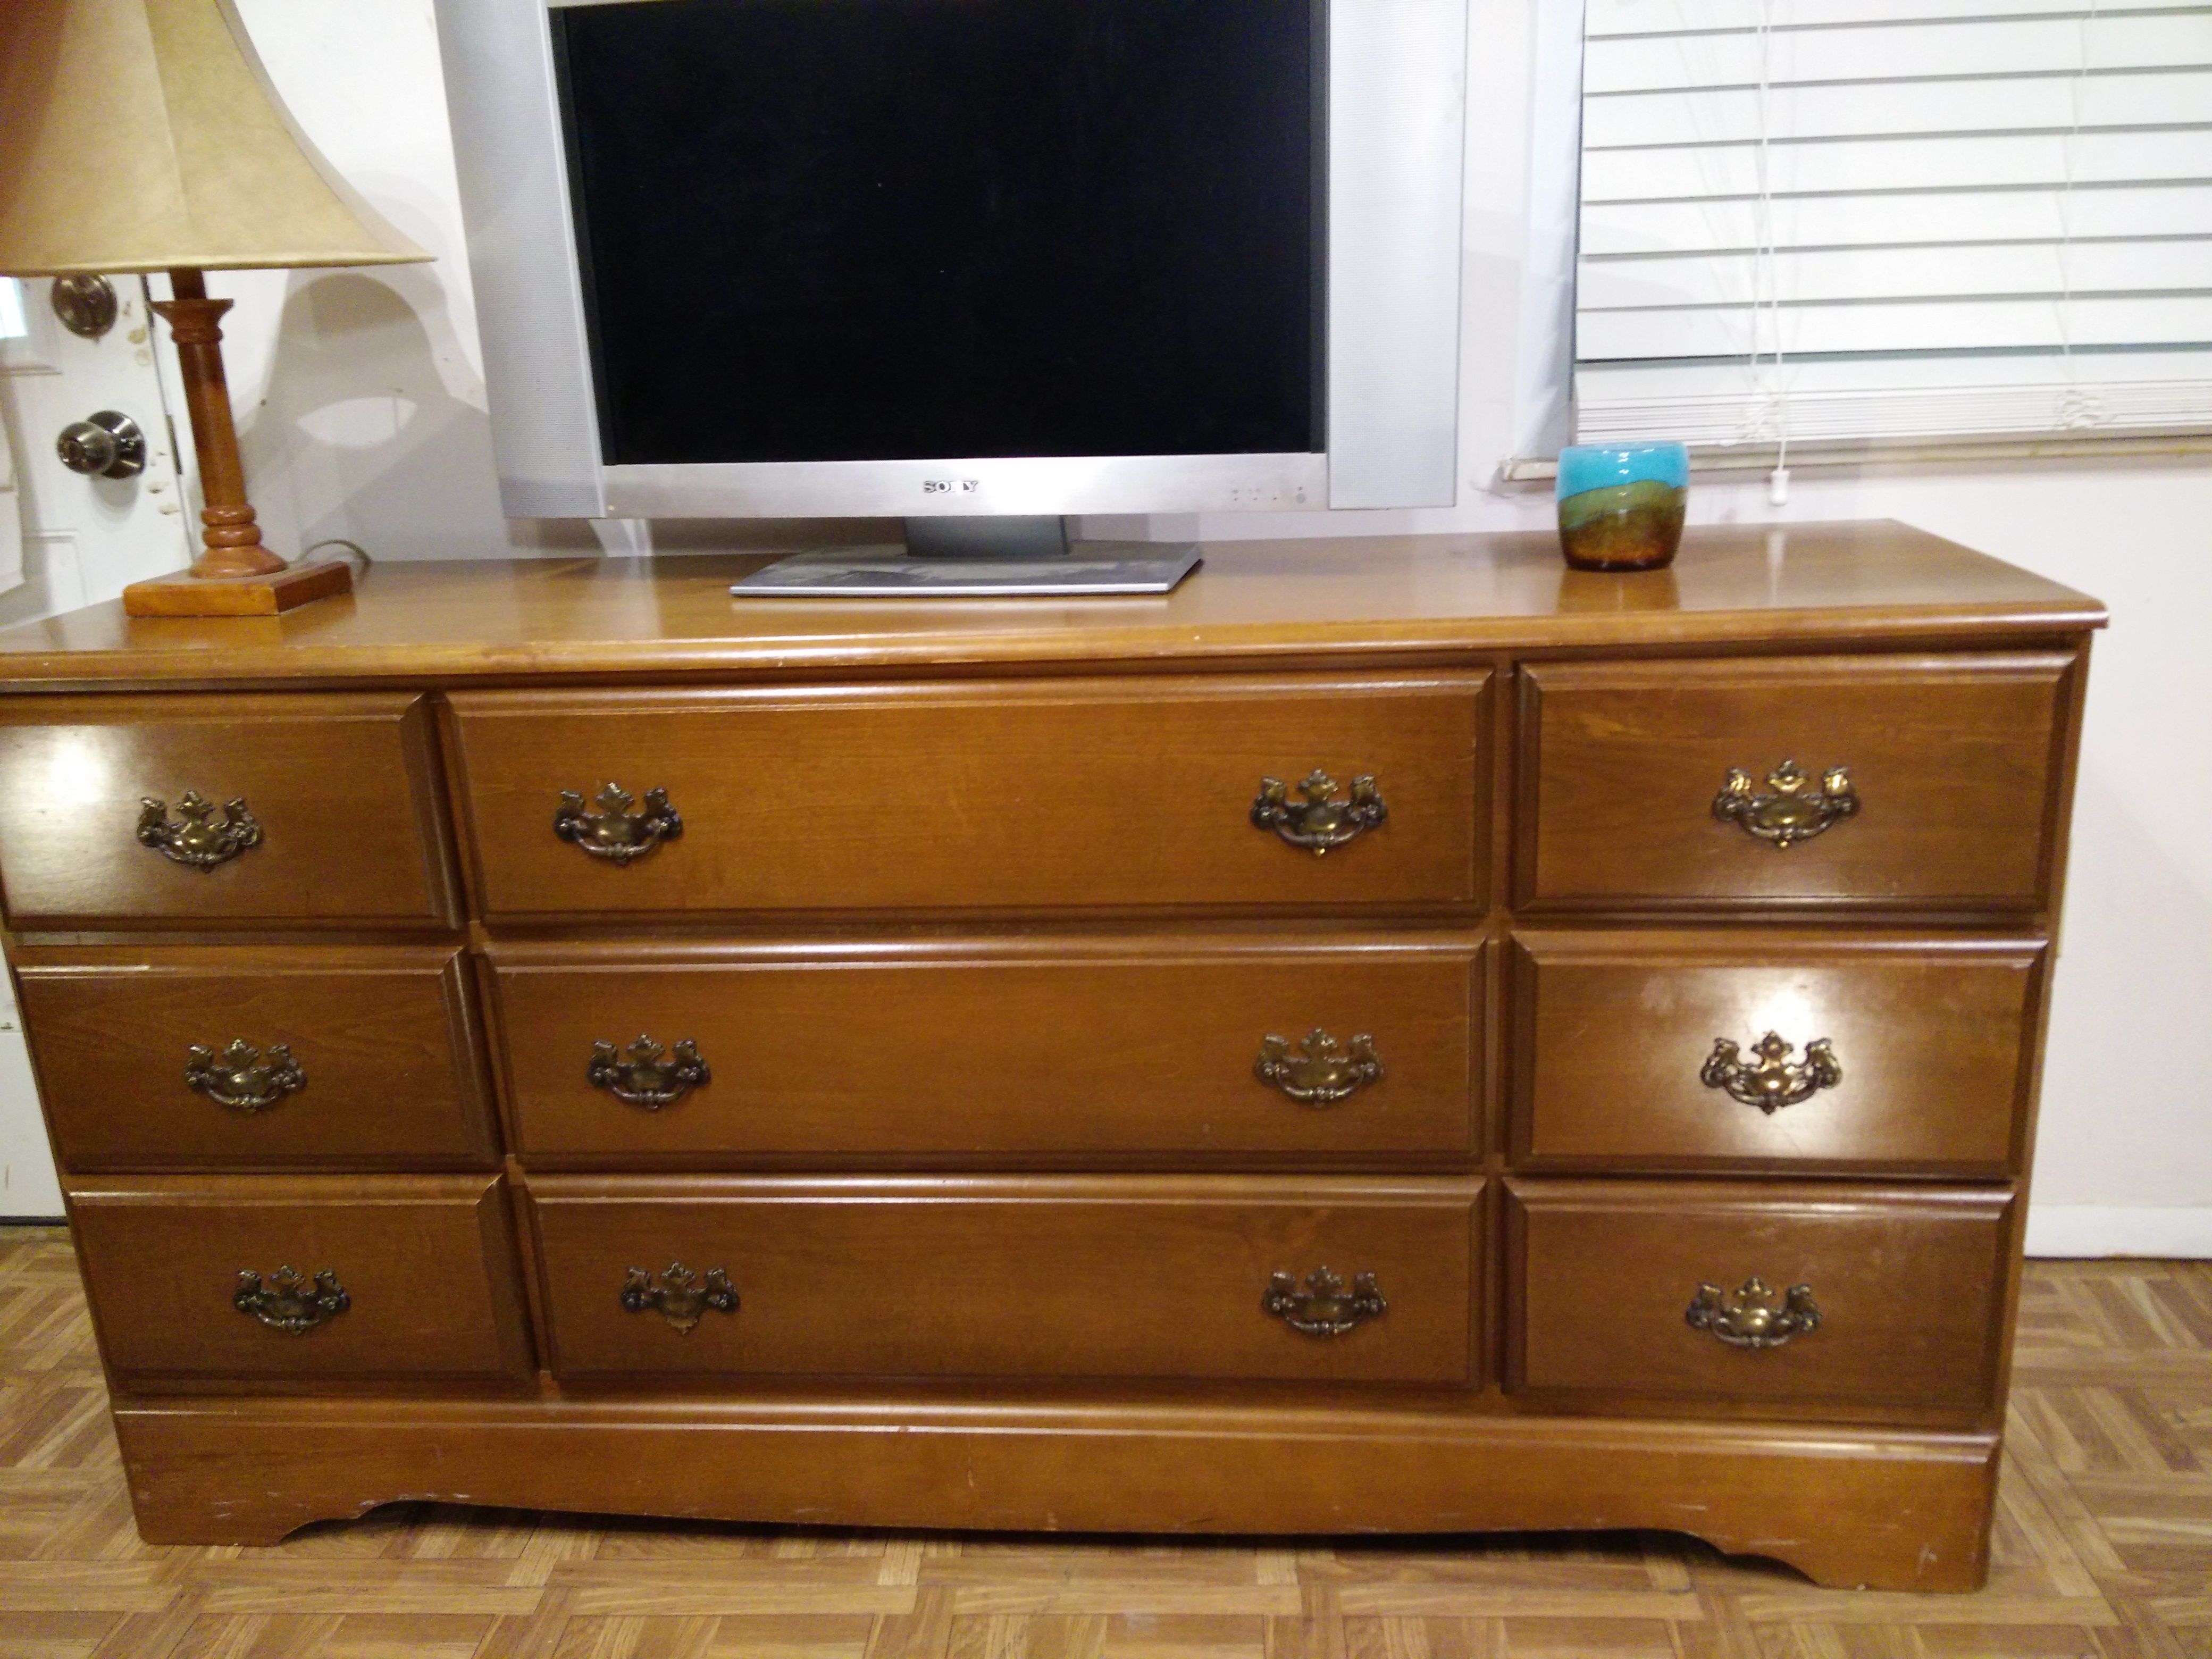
[438,0,1467,517]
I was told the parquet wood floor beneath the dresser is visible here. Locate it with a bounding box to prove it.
[0,1228,2212,1659]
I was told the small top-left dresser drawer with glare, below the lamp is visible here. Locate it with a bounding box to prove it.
[0,692,456,929]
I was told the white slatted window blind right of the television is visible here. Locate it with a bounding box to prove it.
[1575,0,2212,447]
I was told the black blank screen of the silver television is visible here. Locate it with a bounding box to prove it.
[553,0,1325,465]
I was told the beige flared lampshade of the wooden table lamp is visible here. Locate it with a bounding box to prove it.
[0,0,429,276]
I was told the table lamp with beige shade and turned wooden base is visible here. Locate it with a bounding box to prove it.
[0,0,429,617]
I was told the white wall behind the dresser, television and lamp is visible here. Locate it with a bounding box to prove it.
[211,0,2212,1254]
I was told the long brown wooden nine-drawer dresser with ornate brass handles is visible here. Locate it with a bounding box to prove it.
[0,524,2104,1588]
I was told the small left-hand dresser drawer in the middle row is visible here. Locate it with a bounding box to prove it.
[15,944,498,1170]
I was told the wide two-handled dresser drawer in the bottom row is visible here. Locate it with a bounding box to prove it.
[531,1177,1480,1385]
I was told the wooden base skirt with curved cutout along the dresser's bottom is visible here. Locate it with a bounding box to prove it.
[115,1398,1997,1590]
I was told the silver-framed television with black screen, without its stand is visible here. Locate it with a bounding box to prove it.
[438,0,1467,553]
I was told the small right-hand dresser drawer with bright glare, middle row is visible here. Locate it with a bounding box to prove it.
[1509,929,2044,1177]
